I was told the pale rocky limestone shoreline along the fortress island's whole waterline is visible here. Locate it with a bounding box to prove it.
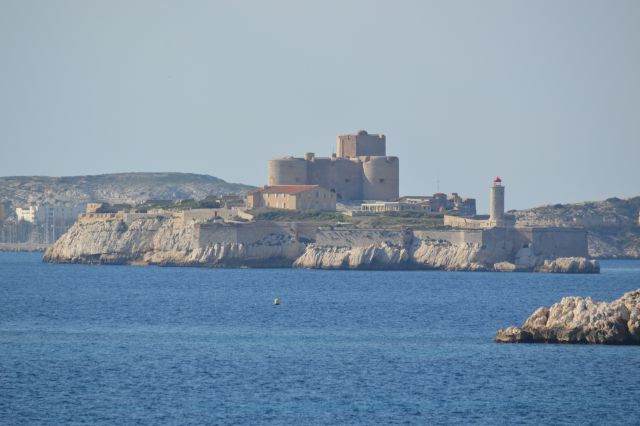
[43,214,599,273]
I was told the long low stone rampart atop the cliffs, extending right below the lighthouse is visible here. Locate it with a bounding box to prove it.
[195,221,588,263]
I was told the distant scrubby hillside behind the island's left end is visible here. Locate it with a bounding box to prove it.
[0,173,253,206]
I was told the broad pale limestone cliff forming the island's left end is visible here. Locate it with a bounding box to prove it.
[44,216,304,267]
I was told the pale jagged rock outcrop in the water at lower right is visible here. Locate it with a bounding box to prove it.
[496,289,640,345]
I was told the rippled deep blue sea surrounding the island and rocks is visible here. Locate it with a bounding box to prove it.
[0,253,640,425]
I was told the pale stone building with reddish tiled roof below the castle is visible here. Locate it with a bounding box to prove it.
[247,185,336,211]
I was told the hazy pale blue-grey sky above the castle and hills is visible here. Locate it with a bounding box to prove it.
[0,0,640,211]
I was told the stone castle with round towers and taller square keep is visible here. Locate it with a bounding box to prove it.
[268,130,400,201]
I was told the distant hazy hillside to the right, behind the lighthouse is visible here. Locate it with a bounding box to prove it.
[513,197,640,258]
